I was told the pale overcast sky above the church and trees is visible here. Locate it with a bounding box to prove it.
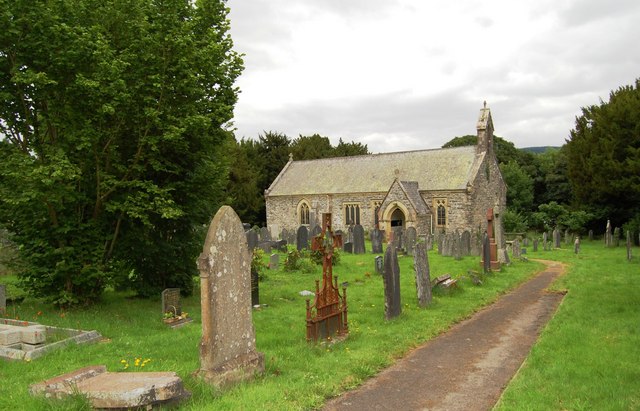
[227,0,640,153]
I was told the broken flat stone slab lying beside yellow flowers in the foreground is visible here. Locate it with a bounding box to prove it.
[29,365,191,409]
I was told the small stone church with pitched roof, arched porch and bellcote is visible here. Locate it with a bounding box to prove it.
[265,103,506,235]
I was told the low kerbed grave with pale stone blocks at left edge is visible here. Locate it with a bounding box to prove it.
[0,318,102,361]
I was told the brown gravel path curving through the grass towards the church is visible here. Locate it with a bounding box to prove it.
[324,260,564,411]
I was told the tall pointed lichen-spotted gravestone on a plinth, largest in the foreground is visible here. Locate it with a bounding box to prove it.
[196,206,264,387]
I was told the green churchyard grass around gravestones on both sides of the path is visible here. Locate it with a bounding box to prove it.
[0,242,640,410]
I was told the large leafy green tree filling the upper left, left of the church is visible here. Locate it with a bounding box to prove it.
[0,0,242,305]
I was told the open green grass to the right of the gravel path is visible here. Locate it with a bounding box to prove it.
[497,240,640,410]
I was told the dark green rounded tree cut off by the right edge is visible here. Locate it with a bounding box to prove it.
[565,80,640,225]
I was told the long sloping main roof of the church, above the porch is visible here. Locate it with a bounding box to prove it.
[266,146,484,196]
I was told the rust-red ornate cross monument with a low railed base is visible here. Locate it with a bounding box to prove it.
[307,213,349,341]
